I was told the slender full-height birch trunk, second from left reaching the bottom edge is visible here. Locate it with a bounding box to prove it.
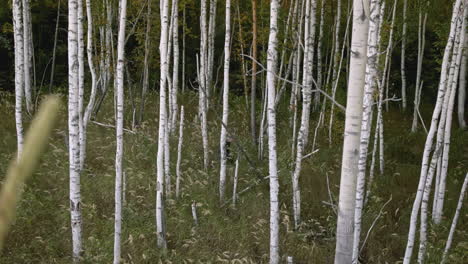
[113,0,127,264]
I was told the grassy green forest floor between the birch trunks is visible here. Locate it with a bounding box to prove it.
[0,92,468,263]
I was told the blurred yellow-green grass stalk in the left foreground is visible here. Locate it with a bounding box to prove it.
[0,96,60,253]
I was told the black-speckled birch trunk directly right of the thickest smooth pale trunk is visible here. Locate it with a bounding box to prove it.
[352,0,380,264]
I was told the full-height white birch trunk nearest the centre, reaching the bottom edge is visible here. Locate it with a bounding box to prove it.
[267,0,280,264]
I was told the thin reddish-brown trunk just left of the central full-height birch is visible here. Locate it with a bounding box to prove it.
[250,0,257,143]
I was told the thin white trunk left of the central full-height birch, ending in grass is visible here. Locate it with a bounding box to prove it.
[219,0,231,202]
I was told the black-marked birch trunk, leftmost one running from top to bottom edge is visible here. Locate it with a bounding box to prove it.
[68,0,82,262]
